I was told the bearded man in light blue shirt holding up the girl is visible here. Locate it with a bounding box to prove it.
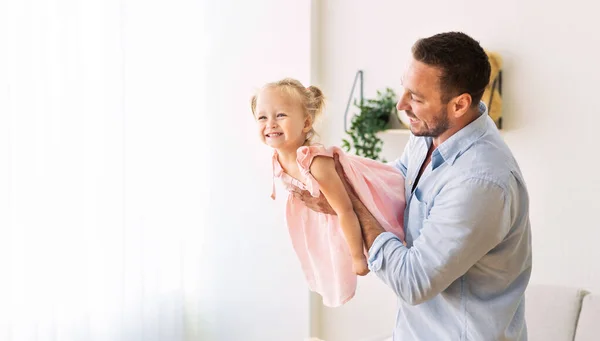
[295,32,531,341]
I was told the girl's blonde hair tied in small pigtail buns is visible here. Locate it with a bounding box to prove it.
[250,78,325,142]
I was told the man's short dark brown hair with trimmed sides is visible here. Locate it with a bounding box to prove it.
[412,32,491,107]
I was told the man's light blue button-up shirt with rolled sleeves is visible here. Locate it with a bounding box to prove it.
[369,103,531,341]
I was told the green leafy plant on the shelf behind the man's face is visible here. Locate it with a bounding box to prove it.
[342,88,397,161]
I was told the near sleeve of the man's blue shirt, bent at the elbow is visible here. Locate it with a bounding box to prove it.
[368,178,511,305]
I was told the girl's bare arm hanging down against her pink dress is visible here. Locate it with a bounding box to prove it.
[310,156,368,275]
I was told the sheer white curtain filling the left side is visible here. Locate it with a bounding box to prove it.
[0,0,209,341]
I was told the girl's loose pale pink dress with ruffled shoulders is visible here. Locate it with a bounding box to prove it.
[271,145,406,307]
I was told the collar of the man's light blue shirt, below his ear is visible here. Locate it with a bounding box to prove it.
[432,102,488,165]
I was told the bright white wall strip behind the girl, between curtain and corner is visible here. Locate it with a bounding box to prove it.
[203,0,311,341]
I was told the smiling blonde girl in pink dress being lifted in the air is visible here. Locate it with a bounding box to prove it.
[251,79,406,307]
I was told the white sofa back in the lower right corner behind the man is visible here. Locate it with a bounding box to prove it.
[372,285,600,341]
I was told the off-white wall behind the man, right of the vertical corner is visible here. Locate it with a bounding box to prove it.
[316,0,600,341]
